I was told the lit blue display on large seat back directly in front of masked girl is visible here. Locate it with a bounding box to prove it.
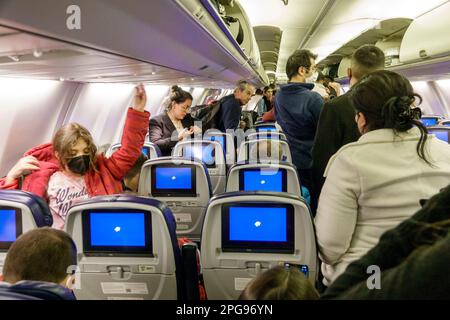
[89,212,145,247]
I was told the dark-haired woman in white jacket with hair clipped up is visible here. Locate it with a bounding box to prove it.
[315,71,450,286]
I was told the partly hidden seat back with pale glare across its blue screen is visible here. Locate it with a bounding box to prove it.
[172,140,227,194]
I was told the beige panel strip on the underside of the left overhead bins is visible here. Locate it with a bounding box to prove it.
[0,27,229,87]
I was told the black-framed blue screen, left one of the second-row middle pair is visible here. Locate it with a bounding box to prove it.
[151,164,197,197]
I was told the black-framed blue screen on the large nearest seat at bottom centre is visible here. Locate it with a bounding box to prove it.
[222,203,295,253]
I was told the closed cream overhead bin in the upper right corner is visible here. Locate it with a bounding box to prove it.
[400,2,450,63]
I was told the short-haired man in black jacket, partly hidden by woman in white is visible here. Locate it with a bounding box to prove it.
[312,45,384,207]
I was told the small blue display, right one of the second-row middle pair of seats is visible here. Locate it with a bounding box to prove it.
[242,170,283,192]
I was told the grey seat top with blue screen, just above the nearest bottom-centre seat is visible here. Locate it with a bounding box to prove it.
[226,163,301,197]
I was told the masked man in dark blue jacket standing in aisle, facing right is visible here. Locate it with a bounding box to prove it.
[274,50,323,196]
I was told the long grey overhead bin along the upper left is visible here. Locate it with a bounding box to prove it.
[0,0,265,84]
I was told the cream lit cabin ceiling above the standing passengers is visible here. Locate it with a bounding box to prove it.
[240,0,448,82]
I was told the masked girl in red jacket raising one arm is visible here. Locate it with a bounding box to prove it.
[0,86,150,229]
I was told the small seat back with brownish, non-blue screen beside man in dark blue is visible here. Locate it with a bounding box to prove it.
[237,139,292,163]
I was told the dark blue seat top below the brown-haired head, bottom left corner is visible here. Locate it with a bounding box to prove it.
[0,281,76,300]
